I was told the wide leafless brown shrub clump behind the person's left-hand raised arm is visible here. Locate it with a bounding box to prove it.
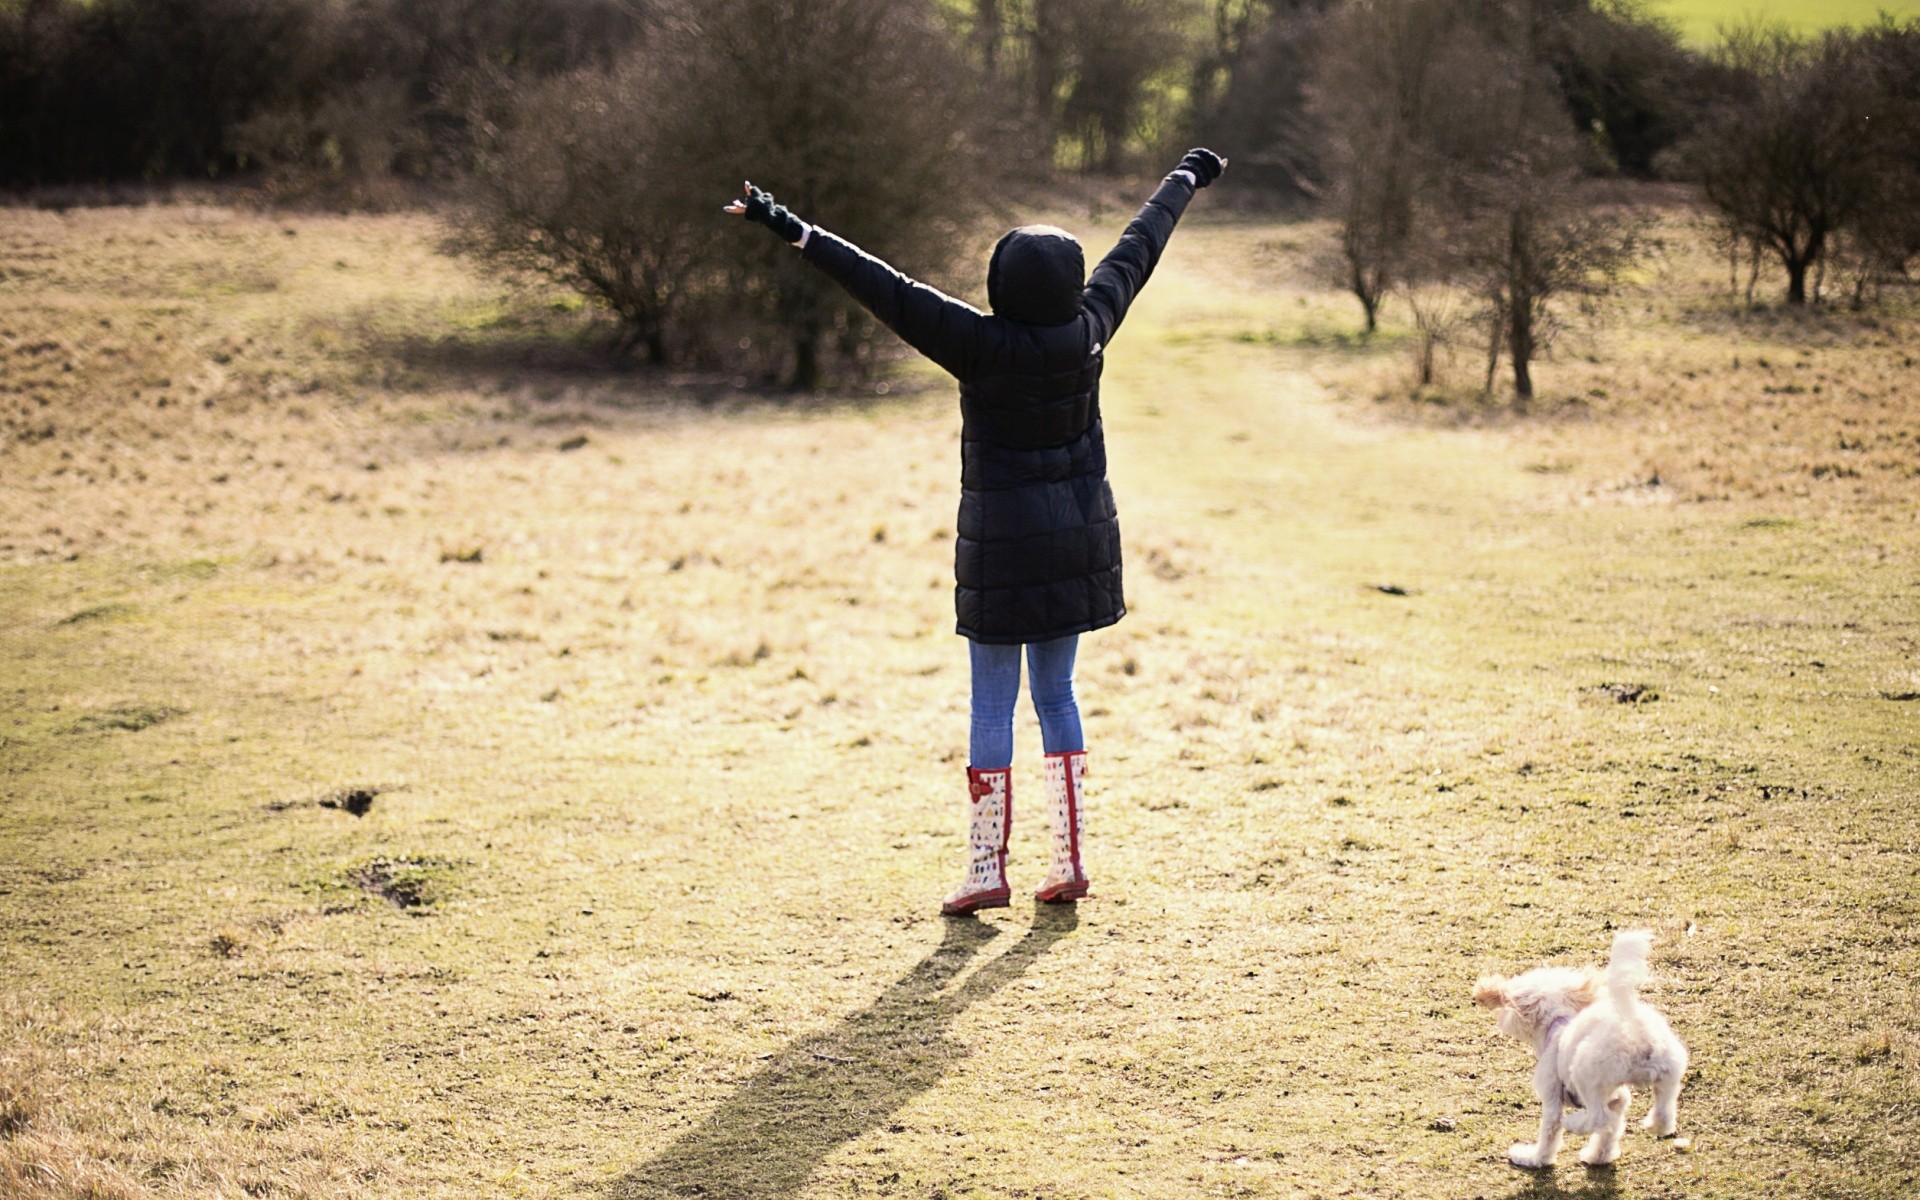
[457,0,985,390]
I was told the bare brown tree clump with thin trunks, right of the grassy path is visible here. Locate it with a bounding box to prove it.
[1317,0,1638,407]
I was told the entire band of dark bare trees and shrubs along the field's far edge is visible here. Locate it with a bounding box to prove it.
[0,0,1920,387]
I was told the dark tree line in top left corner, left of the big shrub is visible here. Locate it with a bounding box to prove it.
[0,0,651,186]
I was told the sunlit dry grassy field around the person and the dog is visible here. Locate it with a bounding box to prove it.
[0,196,1920,1200]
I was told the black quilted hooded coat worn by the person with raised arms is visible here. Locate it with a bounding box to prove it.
[801,177,1194,643]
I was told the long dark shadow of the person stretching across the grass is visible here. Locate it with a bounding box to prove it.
[609,904,1079,1200]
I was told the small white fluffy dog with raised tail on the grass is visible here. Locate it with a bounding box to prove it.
[1473,929,1686,1167]
